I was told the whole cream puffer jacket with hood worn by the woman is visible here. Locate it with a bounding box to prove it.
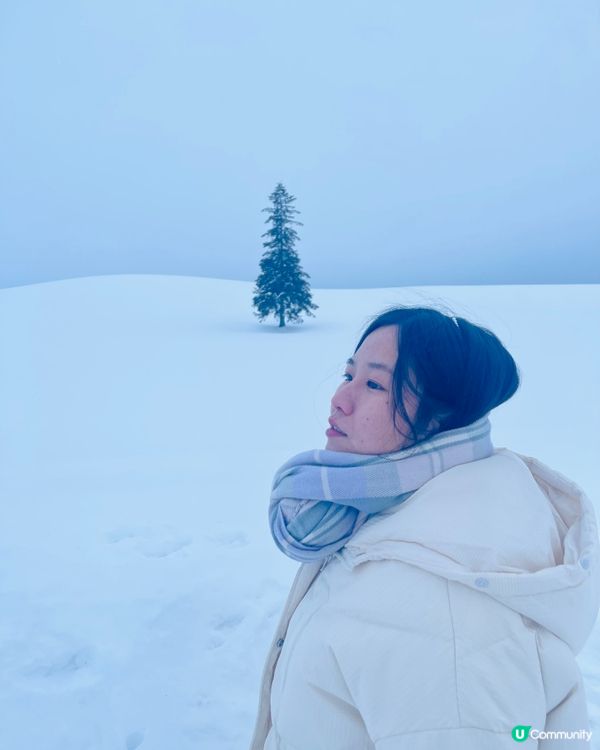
[251,448,600,750]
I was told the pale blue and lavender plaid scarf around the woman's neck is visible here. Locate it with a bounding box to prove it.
[269,412,494,562]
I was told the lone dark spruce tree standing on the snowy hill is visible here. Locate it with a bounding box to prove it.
[252,182,319,328]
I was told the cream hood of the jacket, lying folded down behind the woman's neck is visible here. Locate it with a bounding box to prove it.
[336,448,600,654]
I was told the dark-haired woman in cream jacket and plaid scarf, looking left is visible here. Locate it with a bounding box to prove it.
[251,307,600,750]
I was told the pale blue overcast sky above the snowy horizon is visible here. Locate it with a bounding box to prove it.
[0,0,600,287]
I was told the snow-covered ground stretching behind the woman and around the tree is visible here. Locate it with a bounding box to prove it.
[0,275,600,750]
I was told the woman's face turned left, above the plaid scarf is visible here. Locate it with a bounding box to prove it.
[325,325,418,454]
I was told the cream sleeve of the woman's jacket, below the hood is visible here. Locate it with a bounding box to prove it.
[331,560,546,750]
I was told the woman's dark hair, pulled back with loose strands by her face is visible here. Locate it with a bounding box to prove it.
[354,305,521,447]
